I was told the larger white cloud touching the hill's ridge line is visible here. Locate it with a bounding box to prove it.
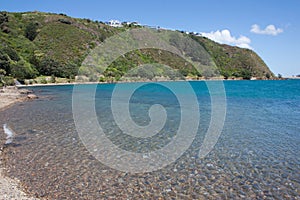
[201,29,252,49]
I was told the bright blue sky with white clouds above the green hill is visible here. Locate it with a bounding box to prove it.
[0,0,300,76]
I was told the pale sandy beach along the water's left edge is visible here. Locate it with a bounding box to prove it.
[0,87,35,200]
